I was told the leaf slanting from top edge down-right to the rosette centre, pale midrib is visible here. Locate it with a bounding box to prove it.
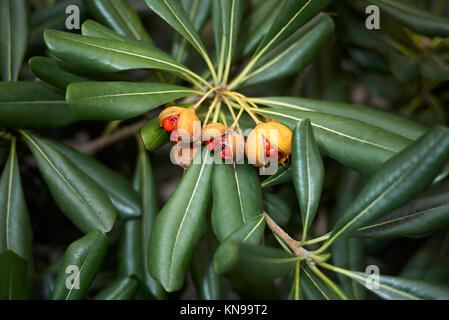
[145,0,212,66]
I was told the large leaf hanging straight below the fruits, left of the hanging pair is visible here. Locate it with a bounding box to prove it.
[148,150,212,292]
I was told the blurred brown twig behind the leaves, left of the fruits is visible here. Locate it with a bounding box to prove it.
[75,120,148,155]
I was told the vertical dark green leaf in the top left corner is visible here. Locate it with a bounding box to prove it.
[0,0,30,81]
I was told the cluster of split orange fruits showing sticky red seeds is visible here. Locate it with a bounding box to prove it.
[159,106,292,168]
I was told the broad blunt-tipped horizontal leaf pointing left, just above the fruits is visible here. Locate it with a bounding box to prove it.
[67,82,197,120]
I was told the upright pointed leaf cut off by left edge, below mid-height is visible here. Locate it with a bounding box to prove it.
[0,141,33,264]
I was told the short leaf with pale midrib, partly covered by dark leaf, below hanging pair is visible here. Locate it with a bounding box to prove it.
[214,214,265,274]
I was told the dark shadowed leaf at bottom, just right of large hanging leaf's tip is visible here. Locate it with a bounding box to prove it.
[190,232,222,300]
